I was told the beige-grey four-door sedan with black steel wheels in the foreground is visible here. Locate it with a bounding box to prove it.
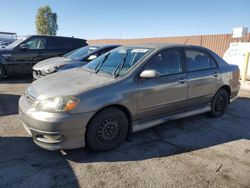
[19,44,240,151]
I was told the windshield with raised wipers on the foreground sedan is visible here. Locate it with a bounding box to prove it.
[84,47,151,77]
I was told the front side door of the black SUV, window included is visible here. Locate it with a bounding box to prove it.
[11,37,46,73]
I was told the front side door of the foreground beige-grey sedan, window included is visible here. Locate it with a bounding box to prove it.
[138,48,187,122]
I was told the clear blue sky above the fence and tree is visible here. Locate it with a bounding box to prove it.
[0,0,250,39]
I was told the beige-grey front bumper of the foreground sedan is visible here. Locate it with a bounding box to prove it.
[19,96,93,150]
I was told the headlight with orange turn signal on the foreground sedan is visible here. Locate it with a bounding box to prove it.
[36,96,80,112]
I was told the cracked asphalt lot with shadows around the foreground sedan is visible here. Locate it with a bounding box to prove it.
[0,76,250,187]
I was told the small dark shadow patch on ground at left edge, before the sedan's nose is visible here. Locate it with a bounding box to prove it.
[0,93,21,116]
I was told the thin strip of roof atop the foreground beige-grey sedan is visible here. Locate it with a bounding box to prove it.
[125,43,203,49]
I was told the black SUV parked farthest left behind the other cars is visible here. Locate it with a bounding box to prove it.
[0,35,87,80]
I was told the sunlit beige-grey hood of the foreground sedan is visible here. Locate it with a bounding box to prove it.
[29,68,114,100]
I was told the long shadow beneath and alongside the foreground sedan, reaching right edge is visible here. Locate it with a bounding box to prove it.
[65,97,250,163]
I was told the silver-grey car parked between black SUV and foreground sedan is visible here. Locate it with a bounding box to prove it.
[33,45,120,79]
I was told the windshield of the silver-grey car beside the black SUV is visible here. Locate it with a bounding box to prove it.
[64,46,99,59]
